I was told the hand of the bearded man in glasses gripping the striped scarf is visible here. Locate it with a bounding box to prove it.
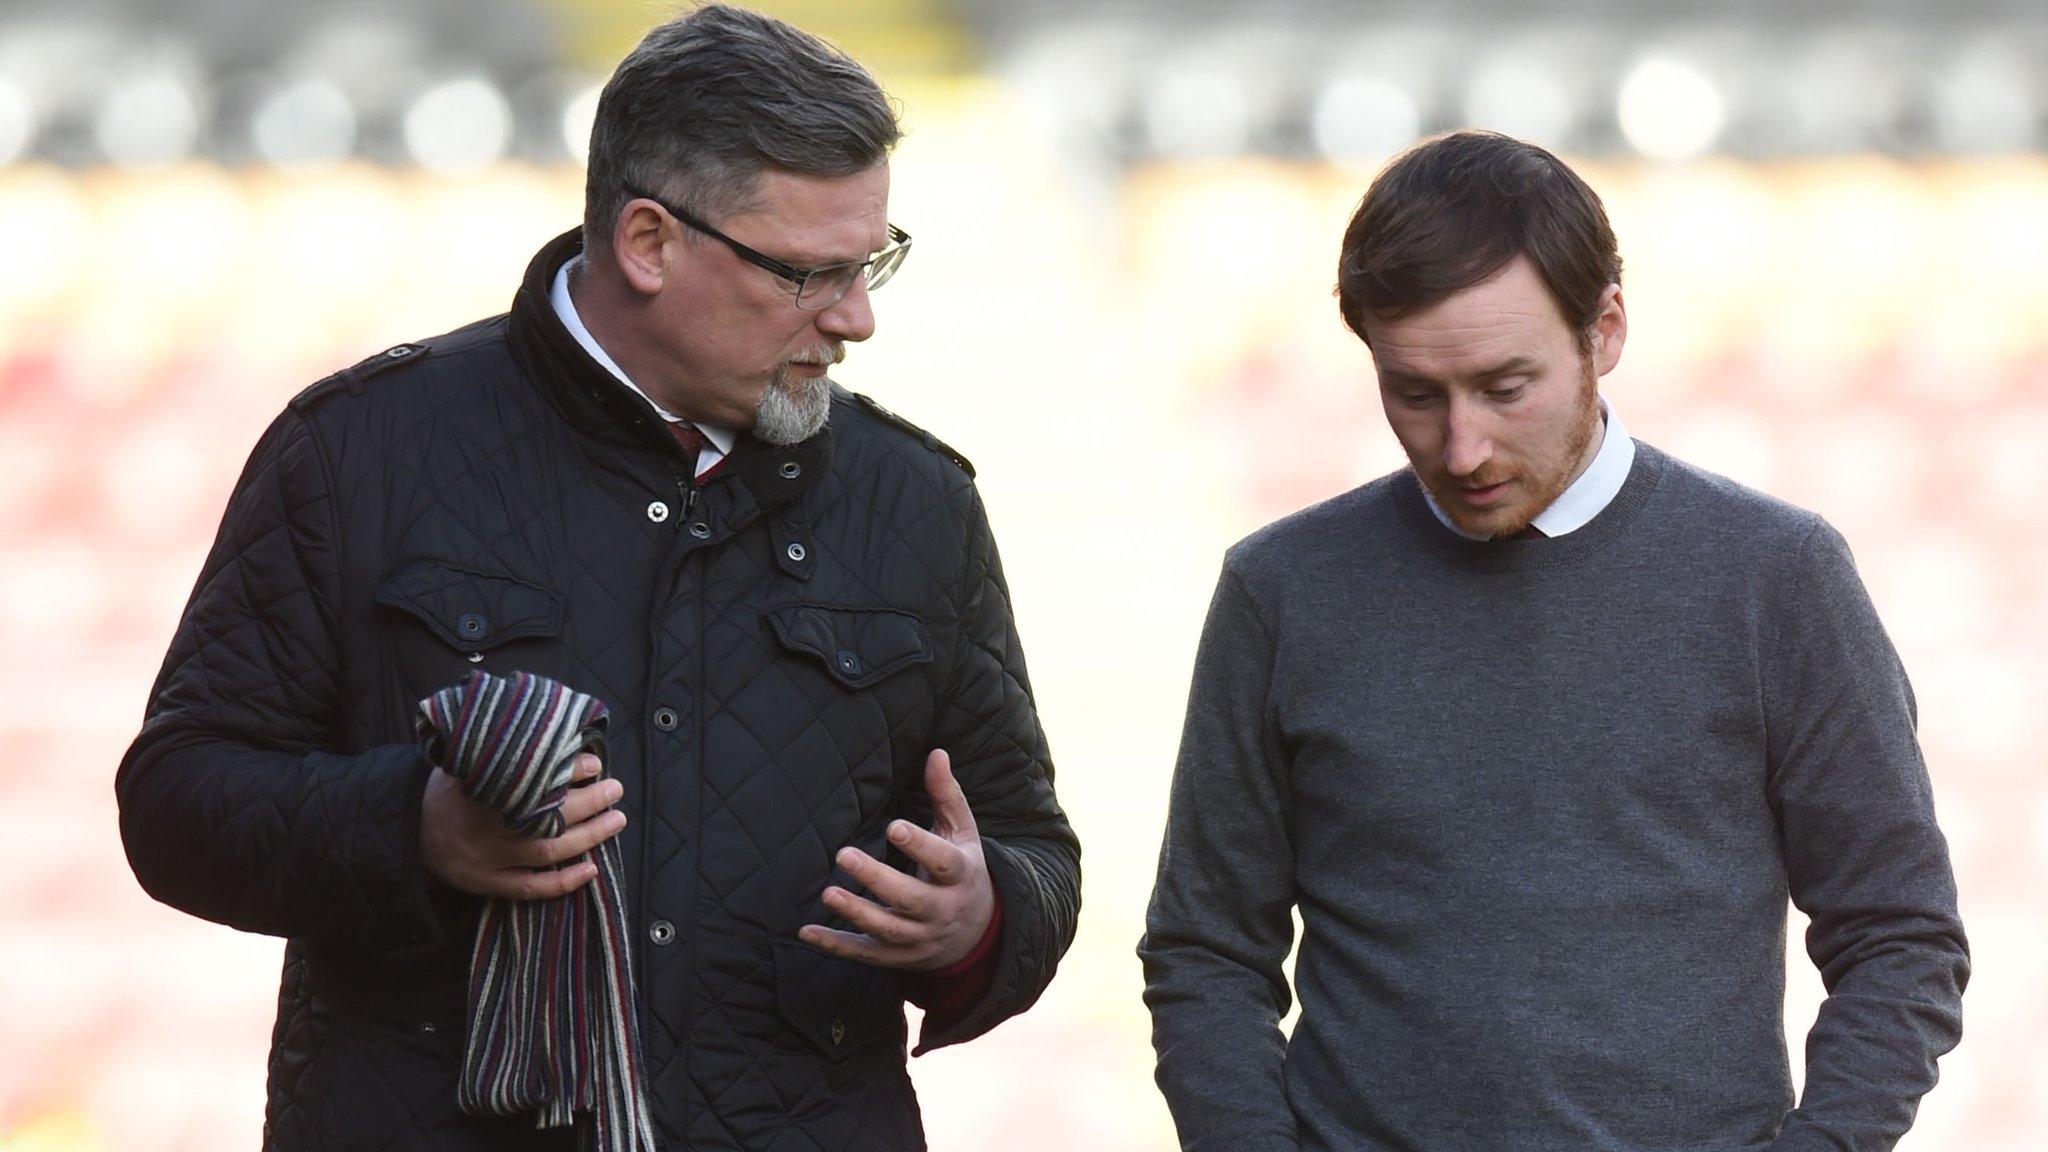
[420,752,627,900]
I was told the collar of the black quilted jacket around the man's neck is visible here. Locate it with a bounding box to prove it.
[508,228,831,508]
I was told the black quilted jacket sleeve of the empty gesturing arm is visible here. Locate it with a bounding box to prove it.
[918,479,1081,1056]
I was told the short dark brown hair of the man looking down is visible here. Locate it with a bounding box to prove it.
[1337,131,1622,348]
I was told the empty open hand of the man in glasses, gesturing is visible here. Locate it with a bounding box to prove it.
[797,750,995,972]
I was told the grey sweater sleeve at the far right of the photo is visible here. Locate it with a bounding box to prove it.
[1763,523,1970,1152]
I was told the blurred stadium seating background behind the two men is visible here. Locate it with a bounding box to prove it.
[0,0,2048,1152]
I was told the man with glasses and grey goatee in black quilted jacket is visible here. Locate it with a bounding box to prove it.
[119,4,1079,1150]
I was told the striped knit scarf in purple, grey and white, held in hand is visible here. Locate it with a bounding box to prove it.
[416,670,655,1152]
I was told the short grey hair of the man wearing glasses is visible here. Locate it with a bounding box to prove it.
[584,4,903,256]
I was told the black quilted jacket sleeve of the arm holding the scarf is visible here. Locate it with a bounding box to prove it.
[115,410,438,951]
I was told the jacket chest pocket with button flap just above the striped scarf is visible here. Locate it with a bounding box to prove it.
[377,560,565,703]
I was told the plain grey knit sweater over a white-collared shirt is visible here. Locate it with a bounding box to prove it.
[1139,445,1968,1152]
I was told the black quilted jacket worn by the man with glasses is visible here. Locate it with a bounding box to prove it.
[117,234,1079,1152]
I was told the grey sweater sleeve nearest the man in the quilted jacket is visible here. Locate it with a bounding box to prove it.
[1139,564,1298,1152]
